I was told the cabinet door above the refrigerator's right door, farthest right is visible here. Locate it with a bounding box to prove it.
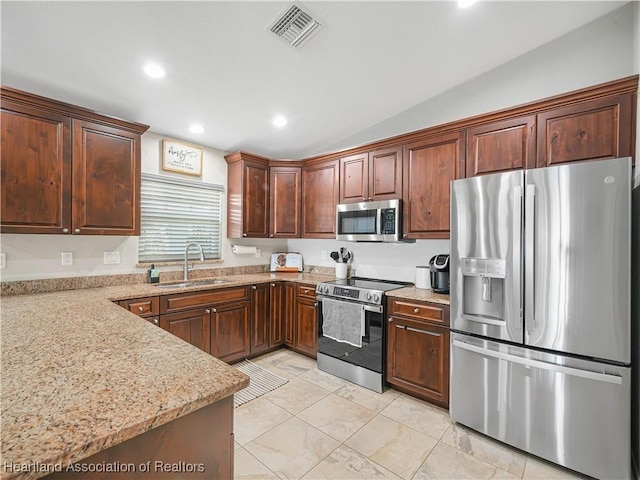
[537,93,635,167]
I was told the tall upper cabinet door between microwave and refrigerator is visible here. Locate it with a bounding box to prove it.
[403,132,464,238]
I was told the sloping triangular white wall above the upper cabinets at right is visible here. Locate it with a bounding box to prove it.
[318,2,638,157]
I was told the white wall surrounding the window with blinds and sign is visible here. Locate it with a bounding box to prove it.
[0,132,287,281]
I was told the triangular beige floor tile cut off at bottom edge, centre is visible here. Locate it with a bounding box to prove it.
[302,445,399,480]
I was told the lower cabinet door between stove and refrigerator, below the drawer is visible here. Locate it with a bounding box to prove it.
[386,316,449,408]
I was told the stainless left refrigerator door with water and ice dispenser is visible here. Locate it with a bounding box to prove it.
[450,171,524,343]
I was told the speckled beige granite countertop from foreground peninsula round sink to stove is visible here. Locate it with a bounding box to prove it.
[0,273,329,480]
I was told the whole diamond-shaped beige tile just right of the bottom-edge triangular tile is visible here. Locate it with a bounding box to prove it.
[345,415,437,479]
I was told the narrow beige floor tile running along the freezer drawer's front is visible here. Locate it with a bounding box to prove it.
[442,423,527,477]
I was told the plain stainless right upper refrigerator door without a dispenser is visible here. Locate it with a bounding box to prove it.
[524,158,631,363]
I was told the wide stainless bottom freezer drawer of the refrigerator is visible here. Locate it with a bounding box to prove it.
[449,334,632,479]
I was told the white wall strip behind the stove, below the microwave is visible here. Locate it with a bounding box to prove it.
[288,239,450,282]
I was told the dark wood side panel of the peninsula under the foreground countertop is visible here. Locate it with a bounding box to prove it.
[44,396,233,480]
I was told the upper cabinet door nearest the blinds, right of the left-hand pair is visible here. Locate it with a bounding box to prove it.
[73,120,140,235]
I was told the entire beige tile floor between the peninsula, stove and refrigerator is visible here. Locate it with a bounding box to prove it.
[235,350,586,480]
